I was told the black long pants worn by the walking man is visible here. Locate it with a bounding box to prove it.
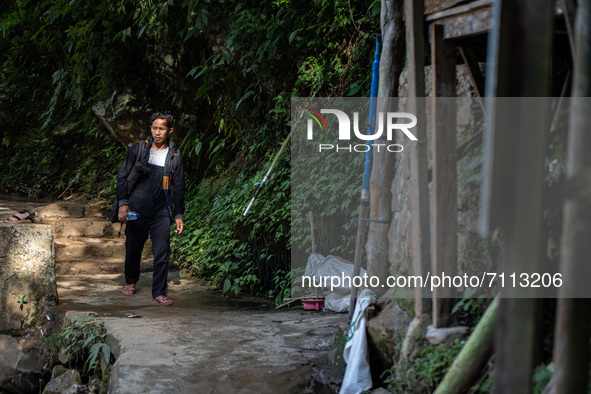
[125,216,170,298]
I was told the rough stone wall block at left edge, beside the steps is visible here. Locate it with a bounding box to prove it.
[0,223,58,330]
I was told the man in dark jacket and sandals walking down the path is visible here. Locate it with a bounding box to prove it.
[117,113,185,305]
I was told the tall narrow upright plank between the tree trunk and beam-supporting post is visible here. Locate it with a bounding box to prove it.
[404,0,431,316]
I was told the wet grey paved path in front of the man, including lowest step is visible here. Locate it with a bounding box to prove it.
[58,273,347,393]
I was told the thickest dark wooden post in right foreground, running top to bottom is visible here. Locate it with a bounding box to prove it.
[480,0,553,394]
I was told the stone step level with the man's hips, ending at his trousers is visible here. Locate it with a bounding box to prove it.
[43,218,125,238]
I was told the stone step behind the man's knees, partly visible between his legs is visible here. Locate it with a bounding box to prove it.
[54,236,152,262]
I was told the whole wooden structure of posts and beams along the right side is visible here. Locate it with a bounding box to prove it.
[405,0,591,393]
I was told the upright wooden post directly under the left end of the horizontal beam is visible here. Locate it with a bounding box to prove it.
[430,24,458,327]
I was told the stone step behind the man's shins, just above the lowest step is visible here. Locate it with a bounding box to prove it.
[55,258,152,277]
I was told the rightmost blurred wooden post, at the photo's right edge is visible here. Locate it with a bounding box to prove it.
[553,1,591,394]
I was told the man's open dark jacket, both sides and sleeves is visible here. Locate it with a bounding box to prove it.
[117,137,185,219]
